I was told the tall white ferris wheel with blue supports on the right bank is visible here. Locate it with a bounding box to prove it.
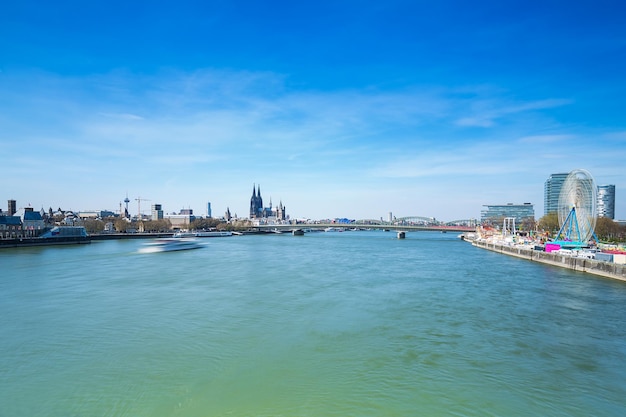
[557,169,597,246]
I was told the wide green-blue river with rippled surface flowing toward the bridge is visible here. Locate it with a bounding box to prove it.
[0,231,626,417]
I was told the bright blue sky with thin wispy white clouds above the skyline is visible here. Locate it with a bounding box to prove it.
[0,0,626,220]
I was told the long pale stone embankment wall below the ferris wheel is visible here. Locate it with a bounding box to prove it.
[472,240,626,281]
